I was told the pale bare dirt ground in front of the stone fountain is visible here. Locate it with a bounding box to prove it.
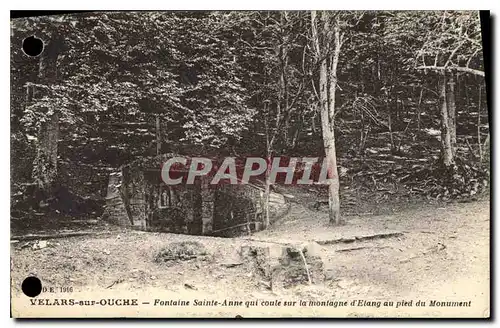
[11,187,490,317]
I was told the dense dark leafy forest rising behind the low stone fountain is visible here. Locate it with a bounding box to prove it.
[10,11,490,234]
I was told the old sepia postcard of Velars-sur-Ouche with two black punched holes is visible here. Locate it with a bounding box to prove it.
[10,10,491,318]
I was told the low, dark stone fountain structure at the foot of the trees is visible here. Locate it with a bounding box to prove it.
[104,154,290,237]
